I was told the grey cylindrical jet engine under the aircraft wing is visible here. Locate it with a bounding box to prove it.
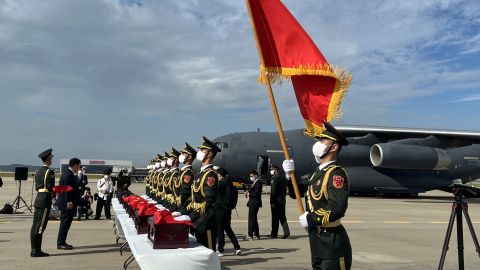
[370,143,452,170]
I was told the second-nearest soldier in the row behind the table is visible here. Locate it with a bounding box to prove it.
[175,143,197,212]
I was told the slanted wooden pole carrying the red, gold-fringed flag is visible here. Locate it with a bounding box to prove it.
[245,0,305,214]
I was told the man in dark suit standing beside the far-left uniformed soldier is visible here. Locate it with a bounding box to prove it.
[57,158,81,250]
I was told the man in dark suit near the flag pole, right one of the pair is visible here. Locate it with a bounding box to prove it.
[268,165,290,239]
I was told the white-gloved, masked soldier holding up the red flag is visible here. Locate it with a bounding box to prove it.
[283,122,352,270]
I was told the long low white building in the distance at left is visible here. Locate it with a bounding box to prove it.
[60,159,133,174]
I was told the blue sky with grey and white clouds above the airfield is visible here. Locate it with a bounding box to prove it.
[0,0,480,164]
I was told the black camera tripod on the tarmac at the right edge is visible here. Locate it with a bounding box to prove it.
[438,187,480,270]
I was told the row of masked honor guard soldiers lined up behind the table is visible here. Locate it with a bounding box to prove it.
[145,137,221,250]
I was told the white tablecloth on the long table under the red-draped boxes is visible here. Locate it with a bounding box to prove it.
[112,198,221,270]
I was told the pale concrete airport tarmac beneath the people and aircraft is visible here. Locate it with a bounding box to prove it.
[0,176,480,270]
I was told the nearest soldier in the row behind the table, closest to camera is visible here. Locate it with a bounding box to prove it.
[177,137,221,250]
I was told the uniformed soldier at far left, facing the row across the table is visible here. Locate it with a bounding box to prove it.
[30,149,55,257]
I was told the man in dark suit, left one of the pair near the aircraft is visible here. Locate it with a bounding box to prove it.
[245,171,263,240]
